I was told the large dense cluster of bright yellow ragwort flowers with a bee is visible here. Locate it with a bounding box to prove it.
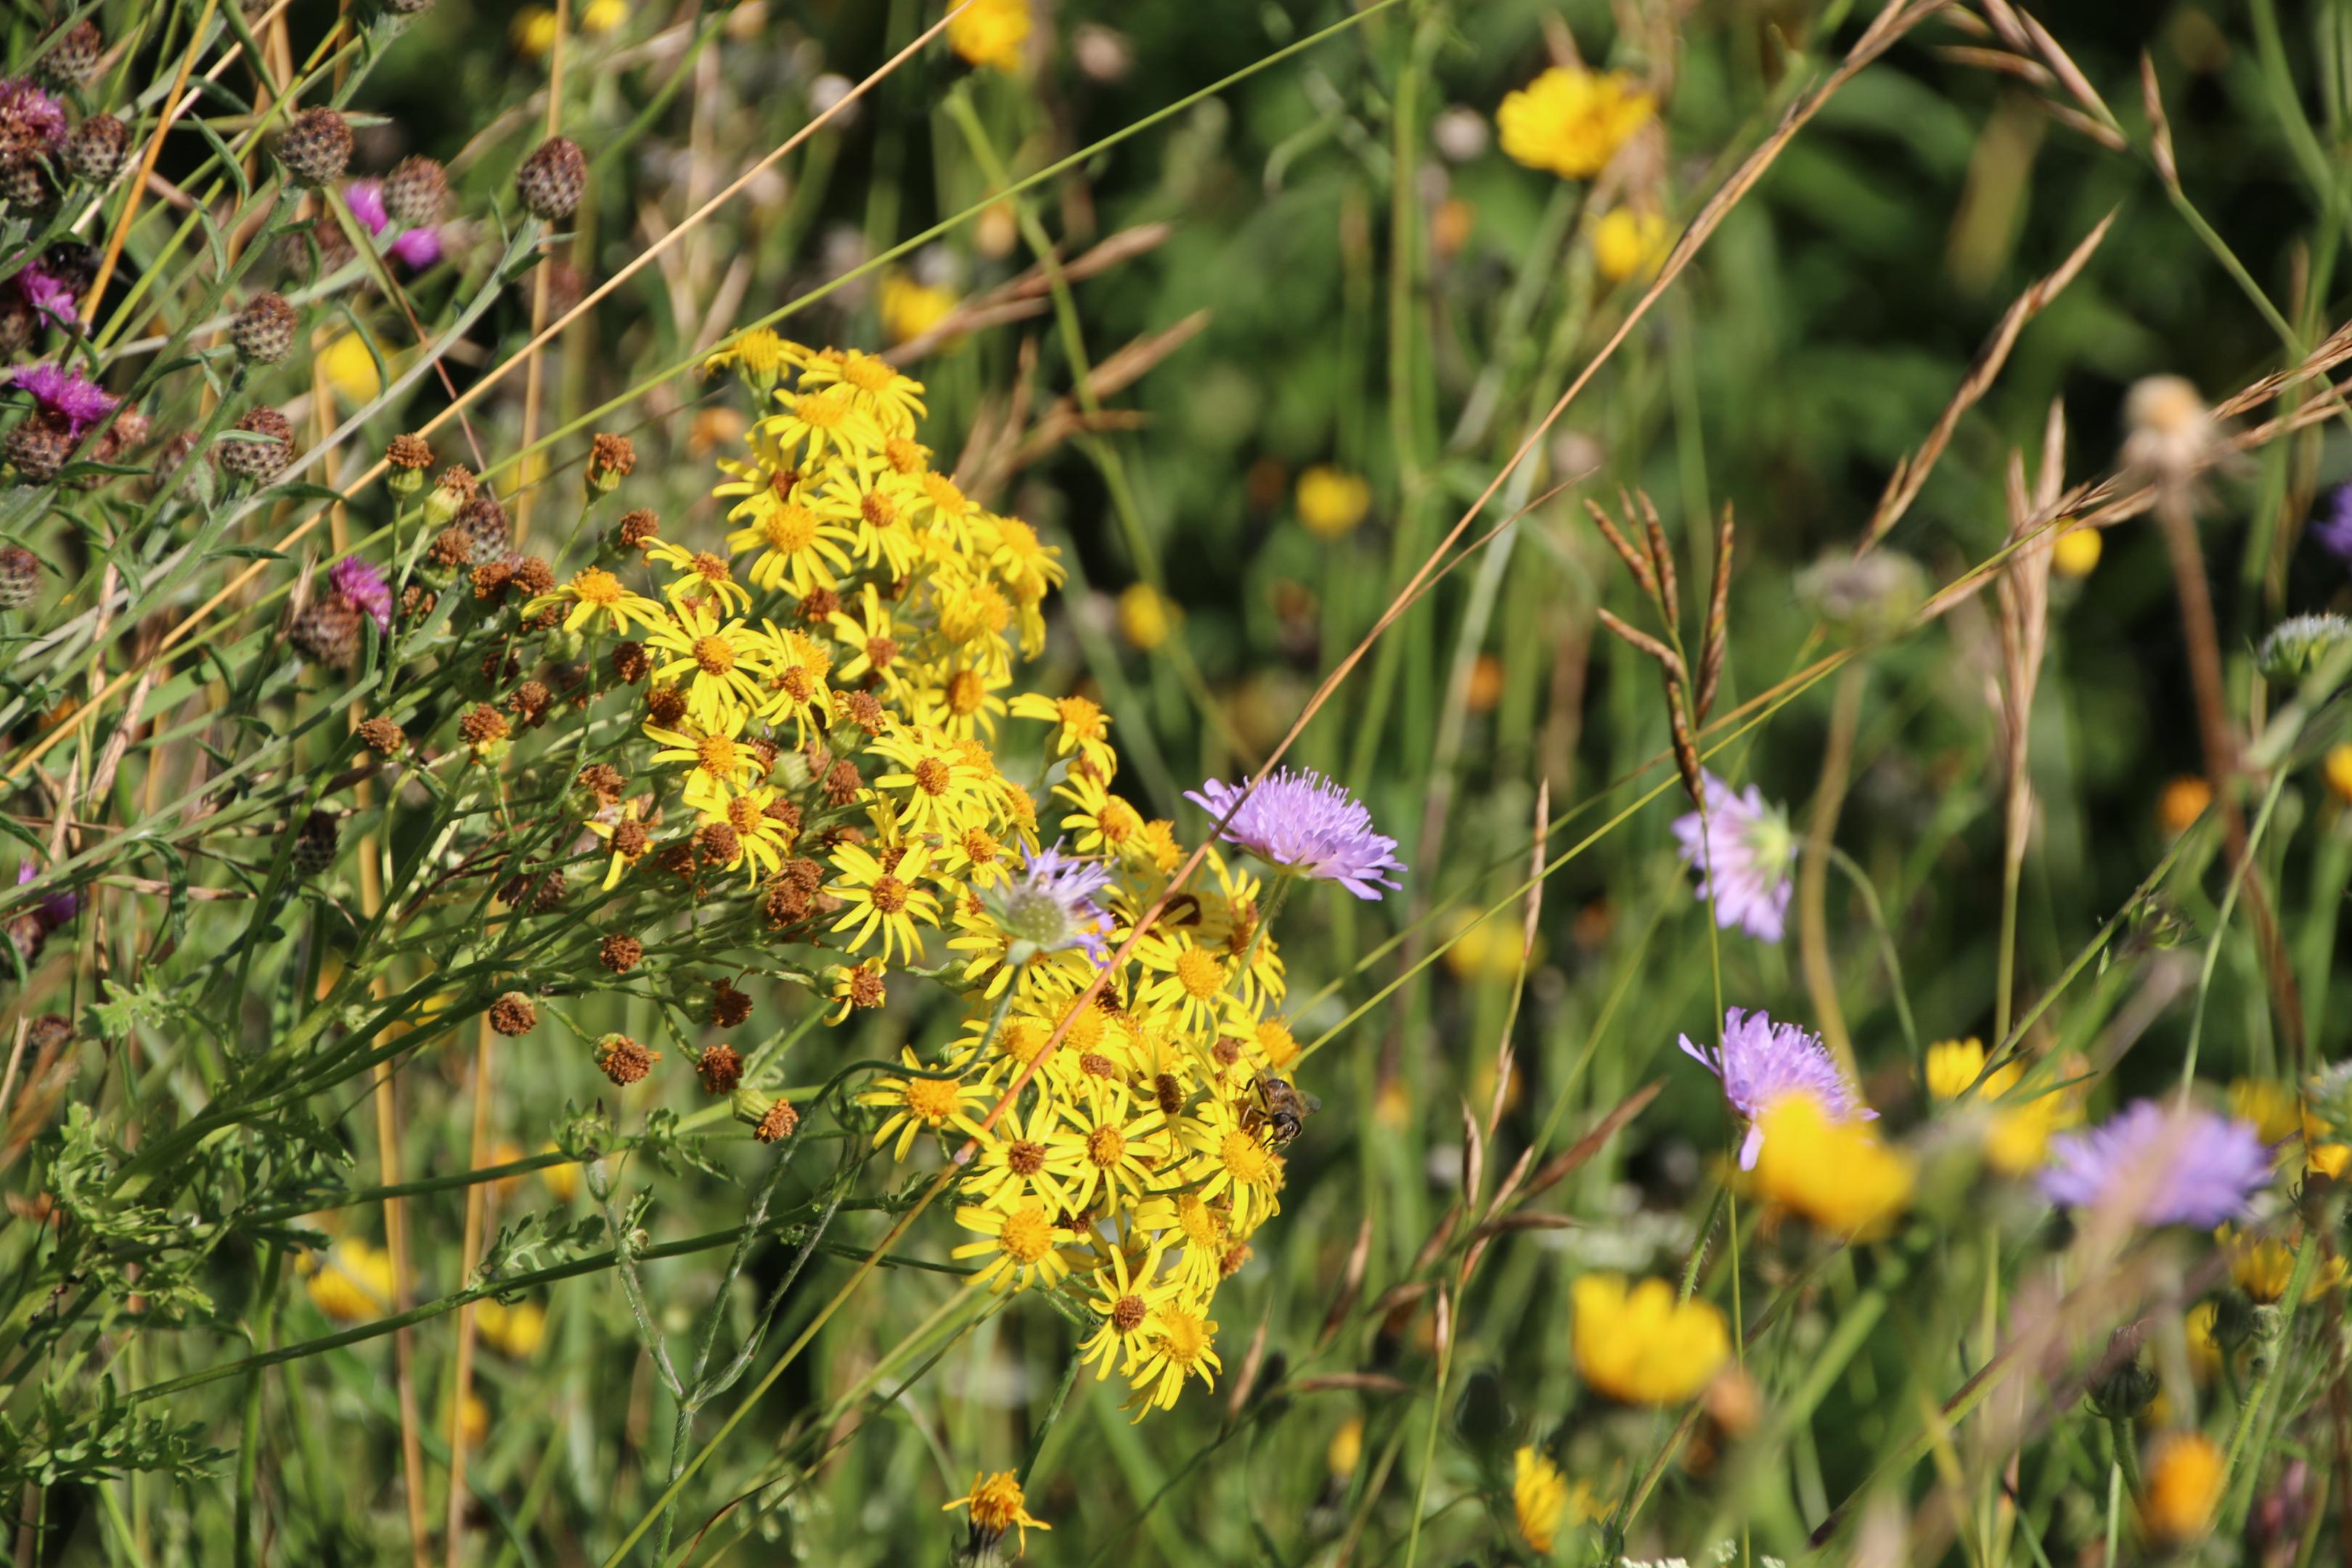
[560,332,1301,1416]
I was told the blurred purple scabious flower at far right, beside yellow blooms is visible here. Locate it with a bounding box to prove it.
[2041,1101,2270,1230]
